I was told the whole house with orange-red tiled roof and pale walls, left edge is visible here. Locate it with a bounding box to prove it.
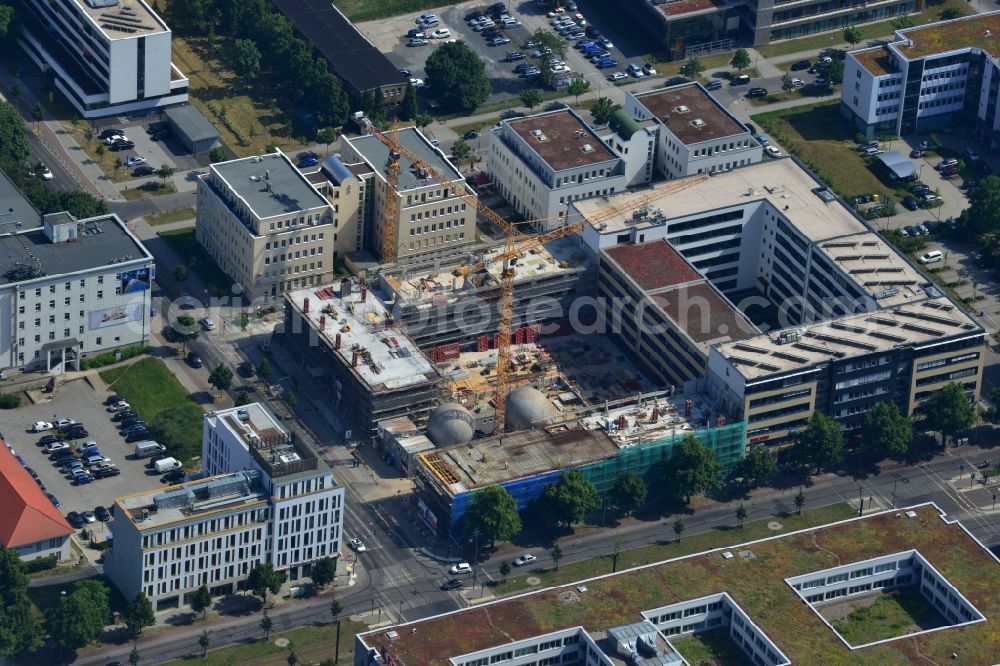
[0,442,73,561]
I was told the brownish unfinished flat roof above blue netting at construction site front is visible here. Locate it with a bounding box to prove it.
[420,426,618,495]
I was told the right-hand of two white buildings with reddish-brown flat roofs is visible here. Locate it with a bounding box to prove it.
[612,83,763,179]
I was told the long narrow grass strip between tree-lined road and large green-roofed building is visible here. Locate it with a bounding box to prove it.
[493,503,855,594]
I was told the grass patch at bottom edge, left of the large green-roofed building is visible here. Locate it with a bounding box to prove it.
[164,620,368,666]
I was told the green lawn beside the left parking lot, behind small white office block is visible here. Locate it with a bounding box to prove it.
[101,358,204,462]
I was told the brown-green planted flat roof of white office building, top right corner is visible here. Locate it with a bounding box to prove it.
[890,12,1000,60]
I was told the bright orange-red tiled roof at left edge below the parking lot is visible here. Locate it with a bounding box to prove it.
[0,446,73,548]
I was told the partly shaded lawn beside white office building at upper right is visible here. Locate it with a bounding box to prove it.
[751,100,897,201]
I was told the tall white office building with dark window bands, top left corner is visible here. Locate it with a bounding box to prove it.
[18,0,188,118]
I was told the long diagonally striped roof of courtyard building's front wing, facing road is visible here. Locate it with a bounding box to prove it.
[716,296,984,379]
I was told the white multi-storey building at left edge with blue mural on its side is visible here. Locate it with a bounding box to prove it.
[0,213,155,372]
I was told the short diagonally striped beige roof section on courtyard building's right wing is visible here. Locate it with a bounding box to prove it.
[816,231,927,309]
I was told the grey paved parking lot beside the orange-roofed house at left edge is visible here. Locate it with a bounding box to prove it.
[0,379,172,515]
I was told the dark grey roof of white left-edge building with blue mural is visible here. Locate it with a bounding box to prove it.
[0,214,152,288]
